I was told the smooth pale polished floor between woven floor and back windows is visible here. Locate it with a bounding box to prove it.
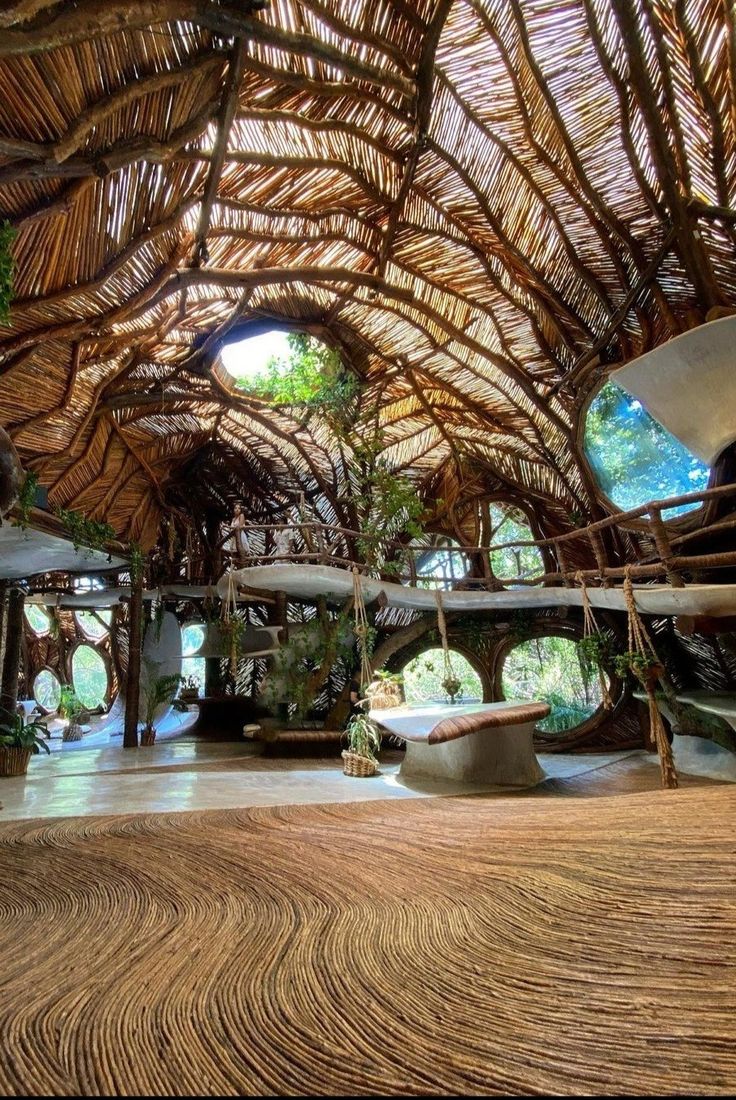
[0,735,711,821]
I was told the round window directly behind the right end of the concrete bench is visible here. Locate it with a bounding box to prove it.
[501,635,603,734]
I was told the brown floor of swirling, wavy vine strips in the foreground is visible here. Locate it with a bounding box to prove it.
[0,785,736,1095]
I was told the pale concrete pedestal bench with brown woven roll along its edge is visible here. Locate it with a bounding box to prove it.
[371,701,550,787]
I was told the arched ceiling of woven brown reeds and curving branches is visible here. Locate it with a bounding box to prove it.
[0,0,736,542]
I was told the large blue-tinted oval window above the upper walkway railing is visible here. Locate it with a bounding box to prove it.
[583,382,711,519]
